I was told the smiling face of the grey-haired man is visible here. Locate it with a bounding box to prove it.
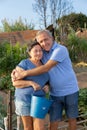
[37,33,53,51]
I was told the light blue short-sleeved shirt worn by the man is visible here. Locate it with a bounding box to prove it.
[42,42,79,96]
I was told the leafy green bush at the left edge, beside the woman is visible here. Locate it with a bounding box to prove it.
[0,42,27,91]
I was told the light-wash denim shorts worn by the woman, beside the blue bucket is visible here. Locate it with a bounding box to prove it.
[15,99,30,116]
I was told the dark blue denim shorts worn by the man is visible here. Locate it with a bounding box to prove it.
[49,92,79,122]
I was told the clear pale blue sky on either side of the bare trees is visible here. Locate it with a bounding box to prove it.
[0,0,87,29]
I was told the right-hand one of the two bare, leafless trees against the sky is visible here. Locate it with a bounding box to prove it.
[49,0,73,26]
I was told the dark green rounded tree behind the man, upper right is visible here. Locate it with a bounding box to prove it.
[56,13,87,44]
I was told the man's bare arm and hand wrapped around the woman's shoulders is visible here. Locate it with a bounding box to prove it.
[11,60,58,80]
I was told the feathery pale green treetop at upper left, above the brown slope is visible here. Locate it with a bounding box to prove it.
[2,17,34,32]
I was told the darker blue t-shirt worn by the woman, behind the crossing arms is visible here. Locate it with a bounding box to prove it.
[15,59,49,102]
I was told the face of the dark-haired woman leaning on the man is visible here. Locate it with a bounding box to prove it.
[29,45,43,60]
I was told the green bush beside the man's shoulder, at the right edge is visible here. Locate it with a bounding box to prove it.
[66,33,87,62]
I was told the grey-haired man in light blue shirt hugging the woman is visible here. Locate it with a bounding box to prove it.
[12,30,79,130]
